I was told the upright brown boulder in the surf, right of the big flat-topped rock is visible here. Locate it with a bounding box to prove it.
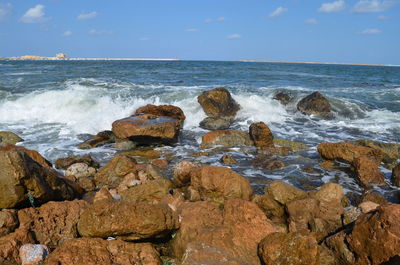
[197,88,240,117]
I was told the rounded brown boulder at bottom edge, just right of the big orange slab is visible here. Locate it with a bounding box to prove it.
[258,233,320,265]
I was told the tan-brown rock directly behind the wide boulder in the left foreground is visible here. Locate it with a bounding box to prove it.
[120,179,173,204]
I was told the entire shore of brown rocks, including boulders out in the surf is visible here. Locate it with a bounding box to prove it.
[0,88,400,265]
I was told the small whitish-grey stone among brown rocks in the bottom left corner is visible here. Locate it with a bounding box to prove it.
[19,244,49,265]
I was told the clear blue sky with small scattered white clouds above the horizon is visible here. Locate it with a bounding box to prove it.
[0,0,400,64]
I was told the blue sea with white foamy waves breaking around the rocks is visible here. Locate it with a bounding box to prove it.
[0,61,400,196]
